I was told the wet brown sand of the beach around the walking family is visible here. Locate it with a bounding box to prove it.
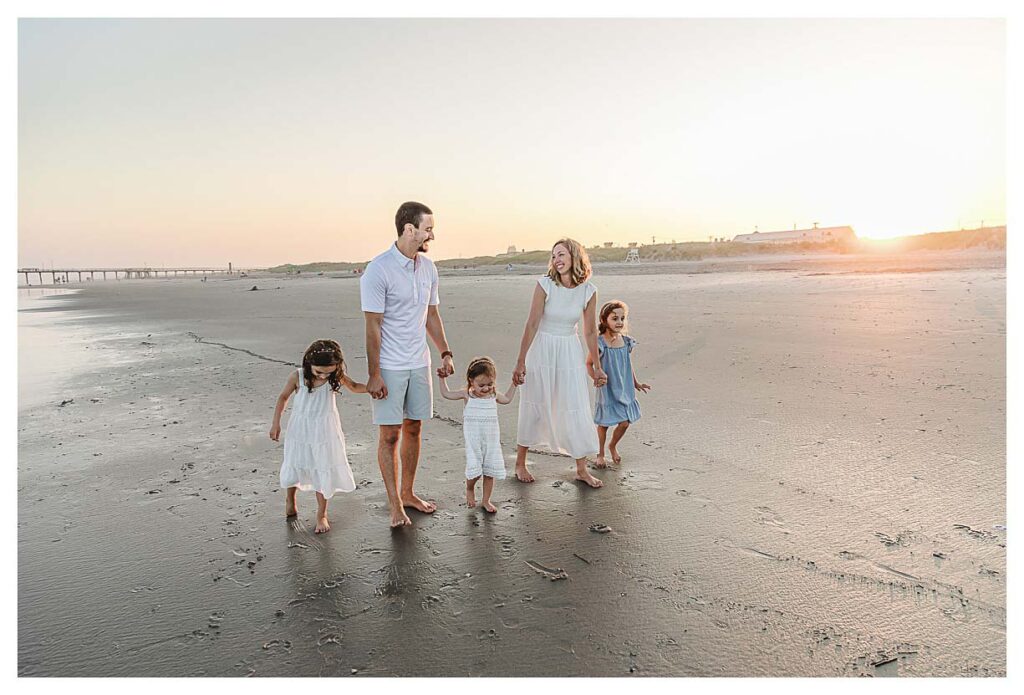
[18,254,1007,677]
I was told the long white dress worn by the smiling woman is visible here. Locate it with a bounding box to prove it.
[517,276,598,459]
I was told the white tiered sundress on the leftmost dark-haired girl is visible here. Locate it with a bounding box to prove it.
[281,368,355,499]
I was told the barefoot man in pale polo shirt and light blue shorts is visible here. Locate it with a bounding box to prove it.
[359,203,455,527]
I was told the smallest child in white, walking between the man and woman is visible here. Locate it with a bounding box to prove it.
[437,357,516,514]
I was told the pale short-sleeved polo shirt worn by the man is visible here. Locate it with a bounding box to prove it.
[359,244,440,370]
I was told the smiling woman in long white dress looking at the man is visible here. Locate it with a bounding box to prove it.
[512,238,607,487]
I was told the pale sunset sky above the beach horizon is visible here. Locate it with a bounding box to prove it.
[18,19,1007,267]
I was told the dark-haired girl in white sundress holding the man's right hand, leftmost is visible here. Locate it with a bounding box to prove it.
[270,340,367,533]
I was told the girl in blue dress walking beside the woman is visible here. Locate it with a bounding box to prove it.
[587,300,650,468]
